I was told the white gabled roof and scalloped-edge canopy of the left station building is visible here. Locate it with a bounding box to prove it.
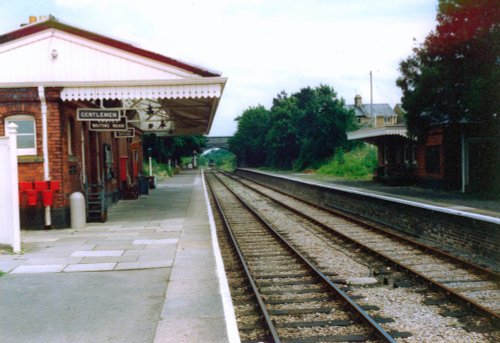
[0,16,226,135]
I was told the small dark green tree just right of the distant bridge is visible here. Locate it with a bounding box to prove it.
[228,105,269,167]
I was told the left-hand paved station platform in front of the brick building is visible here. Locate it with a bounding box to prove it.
[0,170,239,343]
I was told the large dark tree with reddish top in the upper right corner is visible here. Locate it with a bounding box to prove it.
[397,0,500,137]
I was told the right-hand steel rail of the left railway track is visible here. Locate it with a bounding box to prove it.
[214,175,396,343]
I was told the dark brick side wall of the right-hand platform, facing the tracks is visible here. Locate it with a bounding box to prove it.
[236,169,500,268]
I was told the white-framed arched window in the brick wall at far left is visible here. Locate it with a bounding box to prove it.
[5,114,36,155]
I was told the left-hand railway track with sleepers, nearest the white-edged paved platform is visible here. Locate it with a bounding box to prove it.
[207,175,397,342]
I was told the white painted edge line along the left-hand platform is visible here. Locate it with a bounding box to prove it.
[201,169,240,343]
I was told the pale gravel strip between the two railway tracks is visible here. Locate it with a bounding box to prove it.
[221,176,497,342]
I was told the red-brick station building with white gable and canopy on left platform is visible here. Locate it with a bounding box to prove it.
[0,16,226,229]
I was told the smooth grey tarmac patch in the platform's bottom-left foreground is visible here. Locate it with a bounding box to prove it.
[0,268,169,343]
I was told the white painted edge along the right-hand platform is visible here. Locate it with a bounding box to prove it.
[239,168,500,225]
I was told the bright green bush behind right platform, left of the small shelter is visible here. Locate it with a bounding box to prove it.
[316,145,377,180]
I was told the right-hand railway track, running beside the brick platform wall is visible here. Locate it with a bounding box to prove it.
[218,171,500,331]
